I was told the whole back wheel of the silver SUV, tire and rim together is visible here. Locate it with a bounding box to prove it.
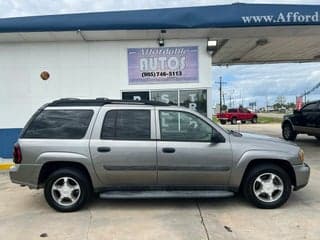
[44,168,91,212]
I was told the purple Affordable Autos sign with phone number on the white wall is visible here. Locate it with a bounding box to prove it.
[128,46,199,84]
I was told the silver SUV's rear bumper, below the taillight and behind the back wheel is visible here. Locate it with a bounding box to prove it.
[9,164,41,188]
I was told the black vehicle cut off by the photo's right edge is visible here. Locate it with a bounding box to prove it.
[282,101,320,141]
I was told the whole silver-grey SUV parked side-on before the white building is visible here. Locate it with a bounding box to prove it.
[10,98,310,212]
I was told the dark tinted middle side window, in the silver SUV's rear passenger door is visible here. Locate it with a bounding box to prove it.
[101,110,151,140]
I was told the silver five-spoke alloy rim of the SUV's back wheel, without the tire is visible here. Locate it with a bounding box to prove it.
[51,177,81,207]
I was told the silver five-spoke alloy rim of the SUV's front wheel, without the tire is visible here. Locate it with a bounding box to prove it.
[253,173,284,203]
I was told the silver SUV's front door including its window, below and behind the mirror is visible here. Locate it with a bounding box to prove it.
[157,110,232,187]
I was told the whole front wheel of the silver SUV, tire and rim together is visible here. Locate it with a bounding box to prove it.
[242,164,292,209]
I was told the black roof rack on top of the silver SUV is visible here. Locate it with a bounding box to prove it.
[47,98,170,107]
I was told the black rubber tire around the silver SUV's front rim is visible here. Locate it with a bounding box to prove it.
[242,164,292,209]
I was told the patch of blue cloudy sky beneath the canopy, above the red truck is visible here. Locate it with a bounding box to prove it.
[212,63,320,107]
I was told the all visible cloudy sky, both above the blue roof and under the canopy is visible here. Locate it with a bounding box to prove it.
[0,0,320,107]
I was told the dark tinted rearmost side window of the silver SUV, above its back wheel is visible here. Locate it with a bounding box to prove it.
[22,110,93,139]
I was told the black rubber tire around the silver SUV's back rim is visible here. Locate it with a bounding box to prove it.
[44,168,92,212]
